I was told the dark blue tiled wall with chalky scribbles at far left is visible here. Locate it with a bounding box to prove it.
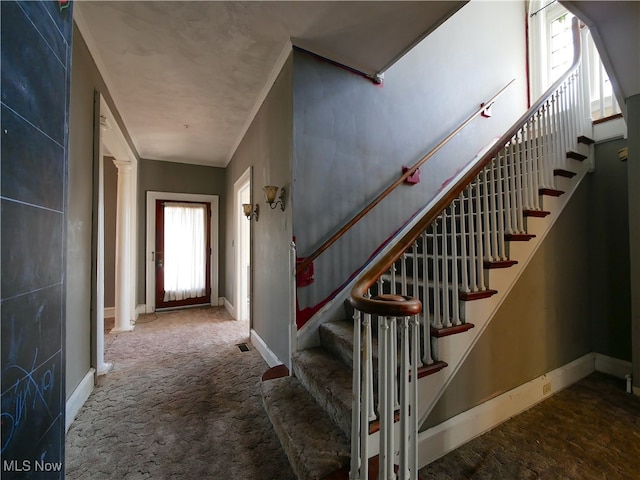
[0,2,73,466]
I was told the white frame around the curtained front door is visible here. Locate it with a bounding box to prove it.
[145,191,220,313]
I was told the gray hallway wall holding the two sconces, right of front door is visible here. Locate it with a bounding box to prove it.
[225,58,293,362]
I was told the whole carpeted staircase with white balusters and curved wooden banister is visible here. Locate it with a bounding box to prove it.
[261,16,593,480]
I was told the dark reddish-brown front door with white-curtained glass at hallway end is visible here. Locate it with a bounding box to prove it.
[155,200,211,308]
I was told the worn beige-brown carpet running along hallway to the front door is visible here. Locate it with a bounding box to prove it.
[66,308,294,480]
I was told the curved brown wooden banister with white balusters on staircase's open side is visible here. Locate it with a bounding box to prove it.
[348,16,584,479]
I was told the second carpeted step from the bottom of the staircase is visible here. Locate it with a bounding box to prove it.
[292,347,353,436]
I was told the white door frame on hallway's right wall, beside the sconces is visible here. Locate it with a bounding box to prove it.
[233,167,253,325]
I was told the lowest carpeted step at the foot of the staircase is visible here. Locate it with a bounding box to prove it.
[260,377,350,480]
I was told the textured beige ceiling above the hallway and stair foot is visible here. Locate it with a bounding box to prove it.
[74,0,466,166]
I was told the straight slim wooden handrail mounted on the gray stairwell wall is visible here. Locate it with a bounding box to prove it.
[296,78,516,273]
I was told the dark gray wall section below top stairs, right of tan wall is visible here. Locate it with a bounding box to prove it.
[589,139,631,361]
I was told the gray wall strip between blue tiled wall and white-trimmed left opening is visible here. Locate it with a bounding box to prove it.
[66,26,135,398]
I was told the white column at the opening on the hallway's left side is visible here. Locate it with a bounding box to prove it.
[112,160,133,333]
